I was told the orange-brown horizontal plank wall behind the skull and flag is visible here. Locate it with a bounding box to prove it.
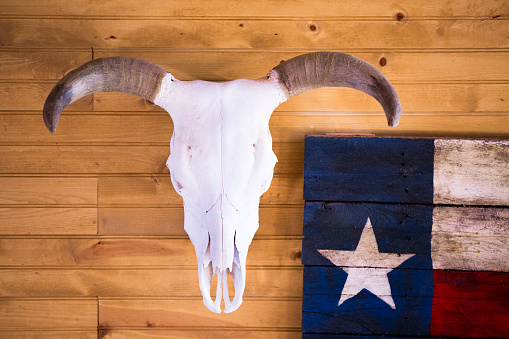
[0,0,509,338]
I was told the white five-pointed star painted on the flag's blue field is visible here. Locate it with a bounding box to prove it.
[318,218,415,309]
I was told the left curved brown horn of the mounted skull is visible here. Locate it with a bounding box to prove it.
[43,57,167,133]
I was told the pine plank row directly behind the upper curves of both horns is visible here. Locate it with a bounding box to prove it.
[0,48,509,83]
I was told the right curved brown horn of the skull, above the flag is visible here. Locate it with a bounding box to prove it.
[273,52,401,127]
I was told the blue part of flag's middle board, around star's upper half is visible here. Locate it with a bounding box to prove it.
[302,202,433,269]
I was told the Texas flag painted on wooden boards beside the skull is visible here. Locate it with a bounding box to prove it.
[302,137,509,338]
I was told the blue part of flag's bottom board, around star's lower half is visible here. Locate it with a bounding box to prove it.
[302,264,433,335]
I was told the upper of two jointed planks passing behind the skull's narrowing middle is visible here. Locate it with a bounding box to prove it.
[99,175,303,207]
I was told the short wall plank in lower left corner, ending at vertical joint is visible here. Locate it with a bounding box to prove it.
[0,298,98,334]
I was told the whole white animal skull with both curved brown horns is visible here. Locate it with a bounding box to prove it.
[43,52,401,313]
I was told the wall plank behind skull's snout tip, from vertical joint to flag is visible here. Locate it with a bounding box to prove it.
[99,299,302,330]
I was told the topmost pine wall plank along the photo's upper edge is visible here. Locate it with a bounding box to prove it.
[0,0,509,19]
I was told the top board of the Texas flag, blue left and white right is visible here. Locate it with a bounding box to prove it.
[304,136,509,206]
